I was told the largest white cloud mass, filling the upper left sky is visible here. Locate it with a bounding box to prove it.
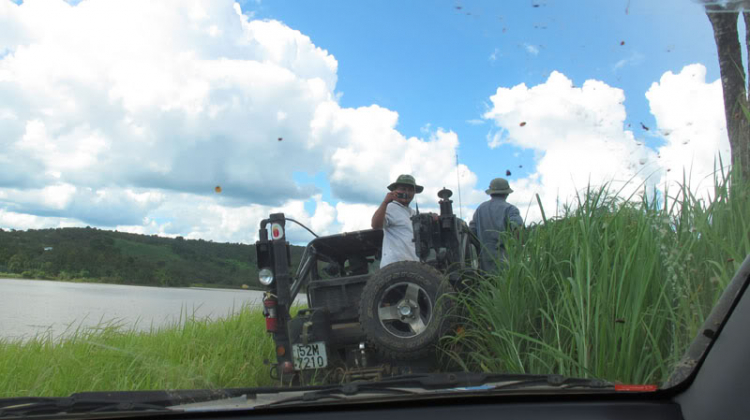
[0,0,337,202]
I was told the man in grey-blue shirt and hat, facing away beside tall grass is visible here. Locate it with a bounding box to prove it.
[469,178,523,272]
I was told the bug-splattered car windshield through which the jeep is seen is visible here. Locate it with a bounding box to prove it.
[0,0,750,414]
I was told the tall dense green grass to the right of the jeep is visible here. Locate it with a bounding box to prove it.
[444,167,750,383]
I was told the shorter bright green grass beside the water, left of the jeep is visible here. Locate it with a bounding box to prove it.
[0,307,273,398]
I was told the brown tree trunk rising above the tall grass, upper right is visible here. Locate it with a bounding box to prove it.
[706,6,750,180]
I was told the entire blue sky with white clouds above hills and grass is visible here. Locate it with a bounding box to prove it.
[0,0,729,243]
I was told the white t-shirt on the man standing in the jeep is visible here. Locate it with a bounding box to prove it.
[380,201,419,268]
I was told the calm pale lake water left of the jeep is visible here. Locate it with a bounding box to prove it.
[0,279,304,339]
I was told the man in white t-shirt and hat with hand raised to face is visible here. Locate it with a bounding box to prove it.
[372,175,424,268]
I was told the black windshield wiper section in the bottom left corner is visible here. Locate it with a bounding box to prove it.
[0,397,174,418]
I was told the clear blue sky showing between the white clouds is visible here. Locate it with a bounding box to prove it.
[243,0,719,207]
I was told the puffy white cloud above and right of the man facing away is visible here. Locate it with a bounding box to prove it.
[484,72,656,220]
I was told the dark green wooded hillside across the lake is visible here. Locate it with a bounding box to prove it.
[0,227,304,288]
